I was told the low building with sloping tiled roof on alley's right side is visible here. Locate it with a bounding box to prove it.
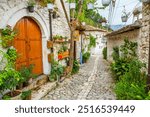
[106,21,141,61]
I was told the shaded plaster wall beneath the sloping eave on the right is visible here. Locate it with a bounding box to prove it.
[107,29,141,62]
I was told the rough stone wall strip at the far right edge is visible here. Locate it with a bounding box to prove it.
[139,4,150,67]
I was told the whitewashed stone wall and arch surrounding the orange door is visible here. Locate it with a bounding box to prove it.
[0,0,70,74]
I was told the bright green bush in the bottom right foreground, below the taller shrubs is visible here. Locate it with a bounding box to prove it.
[115,60,148,100]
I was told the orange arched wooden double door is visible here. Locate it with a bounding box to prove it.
[14,17,43,75]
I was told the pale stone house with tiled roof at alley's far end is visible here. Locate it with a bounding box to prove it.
[76,25,107,60]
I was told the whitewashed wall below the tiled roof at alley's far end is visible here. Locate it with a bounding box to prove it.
[76,31,106,60]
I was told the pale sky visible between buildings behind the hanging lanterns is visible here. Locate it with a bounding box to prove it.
[97,0,142,25]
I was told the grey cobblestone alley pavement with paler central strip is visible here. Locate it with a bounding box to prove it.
[43,56,116,100]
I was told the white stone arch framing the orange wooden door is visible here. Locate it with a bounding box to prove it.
[0,3,50,74]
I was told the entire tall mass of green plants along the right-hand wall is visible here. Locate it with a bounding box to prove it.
[111,39,149,100]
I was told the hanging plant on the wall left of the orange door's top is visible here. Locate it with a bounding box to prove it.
[0,26,17,48]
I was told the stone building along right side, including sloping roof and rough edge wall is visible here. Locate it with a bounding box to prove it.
[106,3,150,68]
